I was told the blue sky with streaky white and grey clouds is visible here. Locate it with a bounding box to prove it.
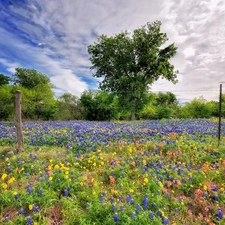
[0,0,225,102]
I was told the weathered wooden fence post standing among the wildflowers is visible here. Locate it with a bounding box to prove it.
[16,91,24,151]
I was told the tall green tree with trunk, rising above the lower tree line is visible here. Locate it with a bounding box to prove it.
[88,21,177,119]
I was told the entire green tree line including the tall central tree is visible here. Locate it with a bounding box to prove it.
[0,21,224,120]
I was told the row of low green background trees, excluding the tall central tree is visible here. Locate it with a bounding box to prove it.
[0,68,225,121]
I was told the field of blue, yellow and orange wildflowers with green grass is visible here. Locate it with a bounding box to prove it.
[0,119,225,225]
